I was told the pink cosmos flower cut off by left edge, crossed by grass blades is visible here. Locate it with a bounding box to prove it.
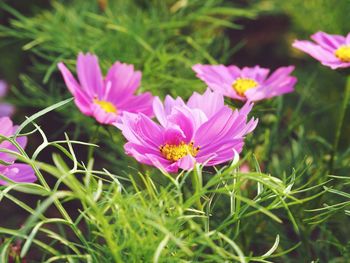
[0,117,36,185]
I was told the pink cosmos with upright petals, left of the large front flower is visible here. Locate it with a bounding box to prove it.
[58,53,153,124]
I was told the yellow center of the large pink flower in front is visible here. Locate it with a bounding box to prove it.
[159,142,199,162]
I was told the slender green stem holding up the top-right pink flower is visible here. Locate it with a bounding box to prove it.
[329,76,350,173]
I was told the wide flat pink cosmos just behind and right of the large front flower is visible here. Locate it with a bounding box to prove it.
[192,64,297,101]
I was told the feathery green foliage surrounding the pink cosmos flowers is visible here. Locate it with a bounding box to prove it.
[0,0,350,263]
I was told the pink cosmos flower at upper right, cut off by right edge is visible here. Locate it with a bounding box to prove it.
[293,32,350,69]
